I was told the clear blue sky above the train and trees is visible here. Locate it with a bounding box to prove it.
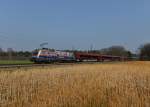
[0,0,150,51]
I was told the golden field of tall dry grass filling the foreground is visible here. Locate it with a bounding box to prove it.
[0,62,150,107]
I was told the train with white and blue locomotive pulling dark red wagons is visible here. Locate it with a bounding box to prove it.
[31,48,127,63]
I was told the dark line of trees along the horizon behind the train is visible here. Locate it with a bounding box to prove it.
[0,43,150,60]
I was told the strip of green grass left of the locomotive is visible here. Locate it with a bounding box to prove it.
[0,60,33,65]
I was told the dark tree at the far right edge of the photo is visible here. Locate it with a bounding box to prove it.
[139,43,150,60]
